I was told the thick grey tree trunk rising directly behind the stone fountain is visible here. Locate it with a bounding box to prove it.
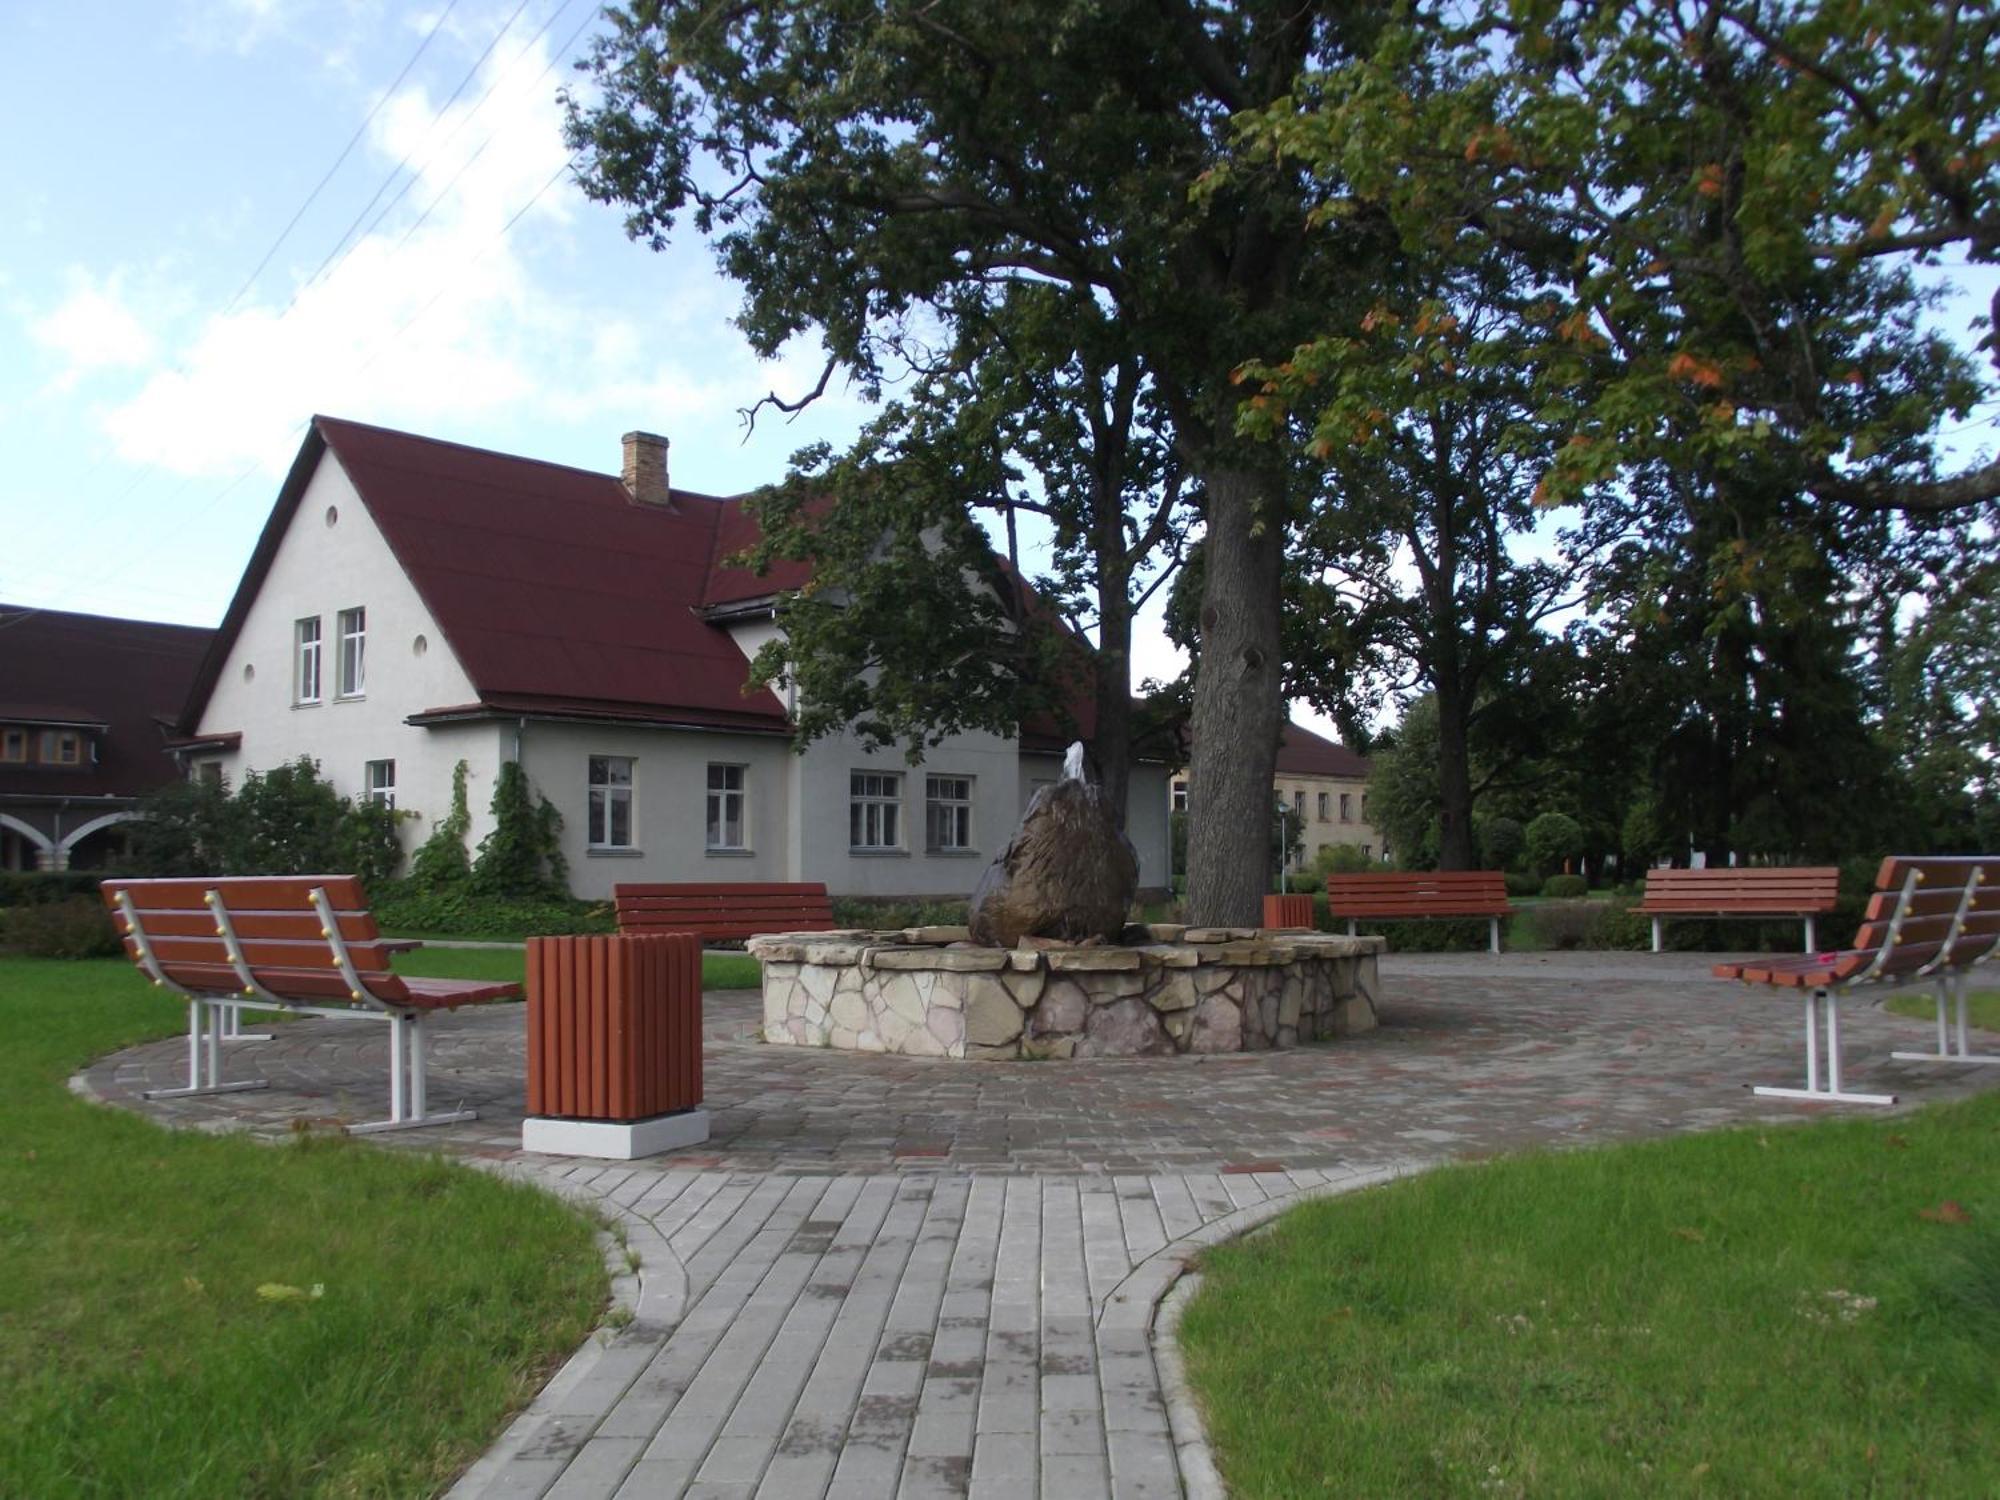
[1188,468,1284,926]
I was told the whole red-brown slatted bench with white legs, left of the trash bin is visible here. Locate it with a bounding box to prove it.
[102,876,520,1134]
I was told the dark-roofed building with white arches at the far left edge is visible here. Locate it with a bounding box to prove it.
[0,604,214,870]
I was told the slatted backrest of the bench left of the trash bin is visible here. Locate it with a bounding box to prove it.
[100,876,410,1006]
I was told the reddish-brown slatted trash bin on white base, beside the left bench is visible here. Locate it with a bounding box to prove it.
[522,932,708,1160]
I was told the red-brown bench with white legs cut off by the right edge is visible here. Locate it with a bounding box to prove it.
[1716,854,2000,1104]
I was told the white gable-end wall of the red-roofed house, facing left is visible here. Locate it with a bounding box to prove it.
[198,452,502,848]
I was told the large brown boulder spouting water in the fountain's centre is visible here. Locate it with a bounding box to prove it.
[972,744,1138,948]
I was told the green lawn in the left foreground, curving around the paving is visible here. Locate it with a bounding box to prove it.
[0,956,606,1500]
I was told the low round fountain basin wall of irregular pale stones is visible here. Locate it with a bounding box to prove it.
[746,924,1384,1060]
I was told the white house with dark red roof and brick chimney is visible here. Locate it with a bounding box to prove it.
[180,416,1168,898]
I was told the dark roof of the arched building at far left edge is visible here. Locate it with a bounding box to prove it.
[0,604,214,798]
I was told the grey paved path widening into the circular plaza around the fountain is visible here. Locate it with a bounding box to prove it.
[84,954,2000,1500]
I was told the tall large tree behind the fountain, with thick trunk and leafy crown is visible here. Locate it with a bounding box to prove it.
[570,0,1390,922]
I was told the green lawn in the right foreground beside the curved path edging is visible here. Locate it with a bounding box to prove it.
[1180,1094,2000,1496]
